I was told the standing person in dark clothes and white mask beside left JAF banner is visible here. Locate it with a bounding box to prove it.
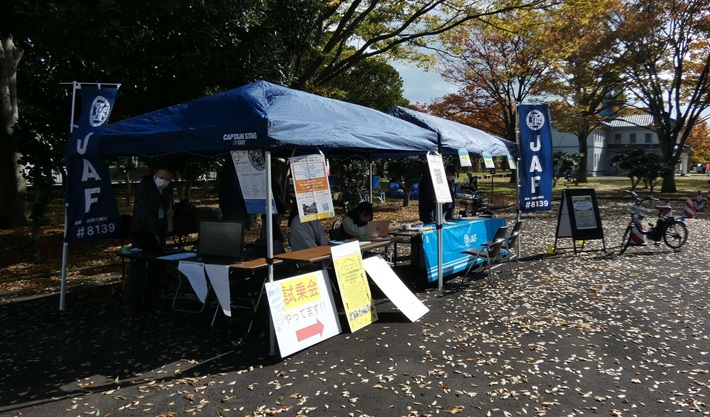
[126,166,175,316]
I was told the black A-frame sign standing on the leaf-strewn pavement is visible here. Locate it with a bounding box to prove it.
[555,188,606,255]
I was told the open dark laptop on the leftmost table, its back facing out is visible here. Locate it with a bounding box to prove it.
[197,220,244,263]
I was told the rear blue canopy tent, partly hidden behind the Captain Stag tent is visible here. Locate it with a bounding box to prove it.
[387,106,518,289]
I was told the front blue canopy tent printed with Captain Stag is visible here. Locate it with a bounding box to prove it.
[60,81,437,322]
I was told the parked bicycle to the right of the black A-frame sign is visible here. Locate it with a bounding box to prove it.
[619,190,688,255]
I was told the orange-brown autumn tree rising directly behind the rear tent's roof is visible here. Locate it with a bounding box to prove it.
[428,10,551,142]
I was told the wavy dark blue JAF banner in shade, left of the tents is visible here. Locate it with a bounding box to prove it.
[64,84,121,243]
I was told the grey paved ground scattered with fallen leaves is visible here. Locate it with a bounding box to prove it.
[0,200,710,416]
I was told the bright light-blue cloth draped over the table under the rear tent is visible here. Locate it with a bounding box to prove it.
[422,217,505,282]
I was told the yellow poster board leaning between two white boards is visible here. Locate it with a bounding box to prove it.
[330,242,377,332]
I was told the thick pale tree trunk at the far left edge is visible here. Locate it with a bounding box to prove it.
[0,37,27,229]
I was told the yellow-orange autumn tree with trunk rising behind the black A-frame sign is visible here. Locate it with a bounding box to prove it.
[543,0,623,183]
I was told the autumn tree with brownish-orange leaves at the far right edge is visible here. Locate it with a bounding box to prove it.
[616,0,710,192]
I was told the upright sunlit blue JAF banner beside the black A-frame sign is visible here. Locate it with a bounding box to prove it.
[518,104,553,212]
